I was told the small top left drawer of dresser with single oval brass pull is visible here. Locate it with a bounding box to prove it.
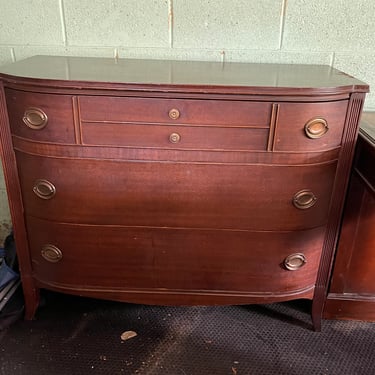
[5,89,75,143]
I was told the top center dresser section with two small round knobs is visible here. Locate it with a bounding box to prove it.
[79,96,272,150]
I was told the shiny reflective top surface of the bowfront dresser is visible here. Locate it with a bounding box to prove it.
[0,56,368,94]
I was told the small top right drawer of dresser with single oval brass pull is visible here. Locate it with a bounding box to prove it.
[274,100,348,152]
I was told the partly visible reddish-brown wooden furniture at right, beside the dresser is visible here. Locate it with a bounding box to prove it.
[324,113,375,321]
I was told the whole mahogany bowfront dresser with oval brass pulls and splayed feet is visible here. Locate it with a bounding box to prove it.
[0,56,368,330]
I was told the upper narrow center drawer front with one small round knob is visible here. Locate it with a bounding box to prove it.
[79,96,271,128]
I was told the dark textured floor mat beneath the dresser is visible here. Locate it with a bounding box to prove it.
[0,293,375,375]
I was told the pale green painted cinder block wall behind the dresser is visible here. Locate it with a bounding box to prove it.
[0,0,375,244]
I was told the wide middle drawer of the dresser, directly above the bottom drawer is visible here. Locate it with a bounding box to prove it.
[17,152,336,230]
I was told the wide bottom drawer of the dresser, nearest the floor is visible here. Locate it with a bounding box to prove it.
[27,217,324,295]
